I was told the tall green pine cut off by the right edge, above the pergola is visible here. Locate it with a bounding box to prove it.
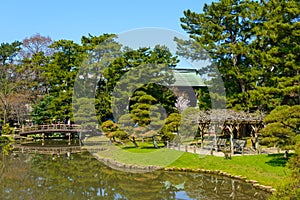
[250,0,300,111]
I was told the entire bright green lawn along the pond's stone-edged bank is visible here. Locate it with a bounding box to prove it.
[93,142,290,188]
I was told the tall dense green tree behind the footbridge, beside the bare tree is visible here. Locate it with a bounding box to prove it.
[42,40,86,121]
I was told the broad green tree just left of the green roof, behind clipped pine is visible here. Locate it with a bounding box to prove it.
[108,45,178,120]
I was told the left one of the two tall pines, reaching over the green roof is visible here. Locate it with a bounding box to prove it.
[178,0,259,109]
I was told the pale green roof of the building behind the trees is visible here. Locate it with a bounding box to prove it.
[172,70,205,87]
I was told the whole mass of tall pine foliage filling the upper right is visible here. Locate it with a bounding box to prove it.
[176,0,300,112]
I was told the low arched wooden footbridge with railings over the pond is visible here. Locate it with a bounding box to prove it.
[19,124,97,136]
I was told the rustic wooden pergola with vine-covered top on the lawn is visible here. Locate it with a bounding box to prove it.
[198,109,264,154]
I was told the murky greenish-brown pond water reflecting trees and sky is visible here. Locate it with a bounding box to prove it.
[0,145,269,200]
